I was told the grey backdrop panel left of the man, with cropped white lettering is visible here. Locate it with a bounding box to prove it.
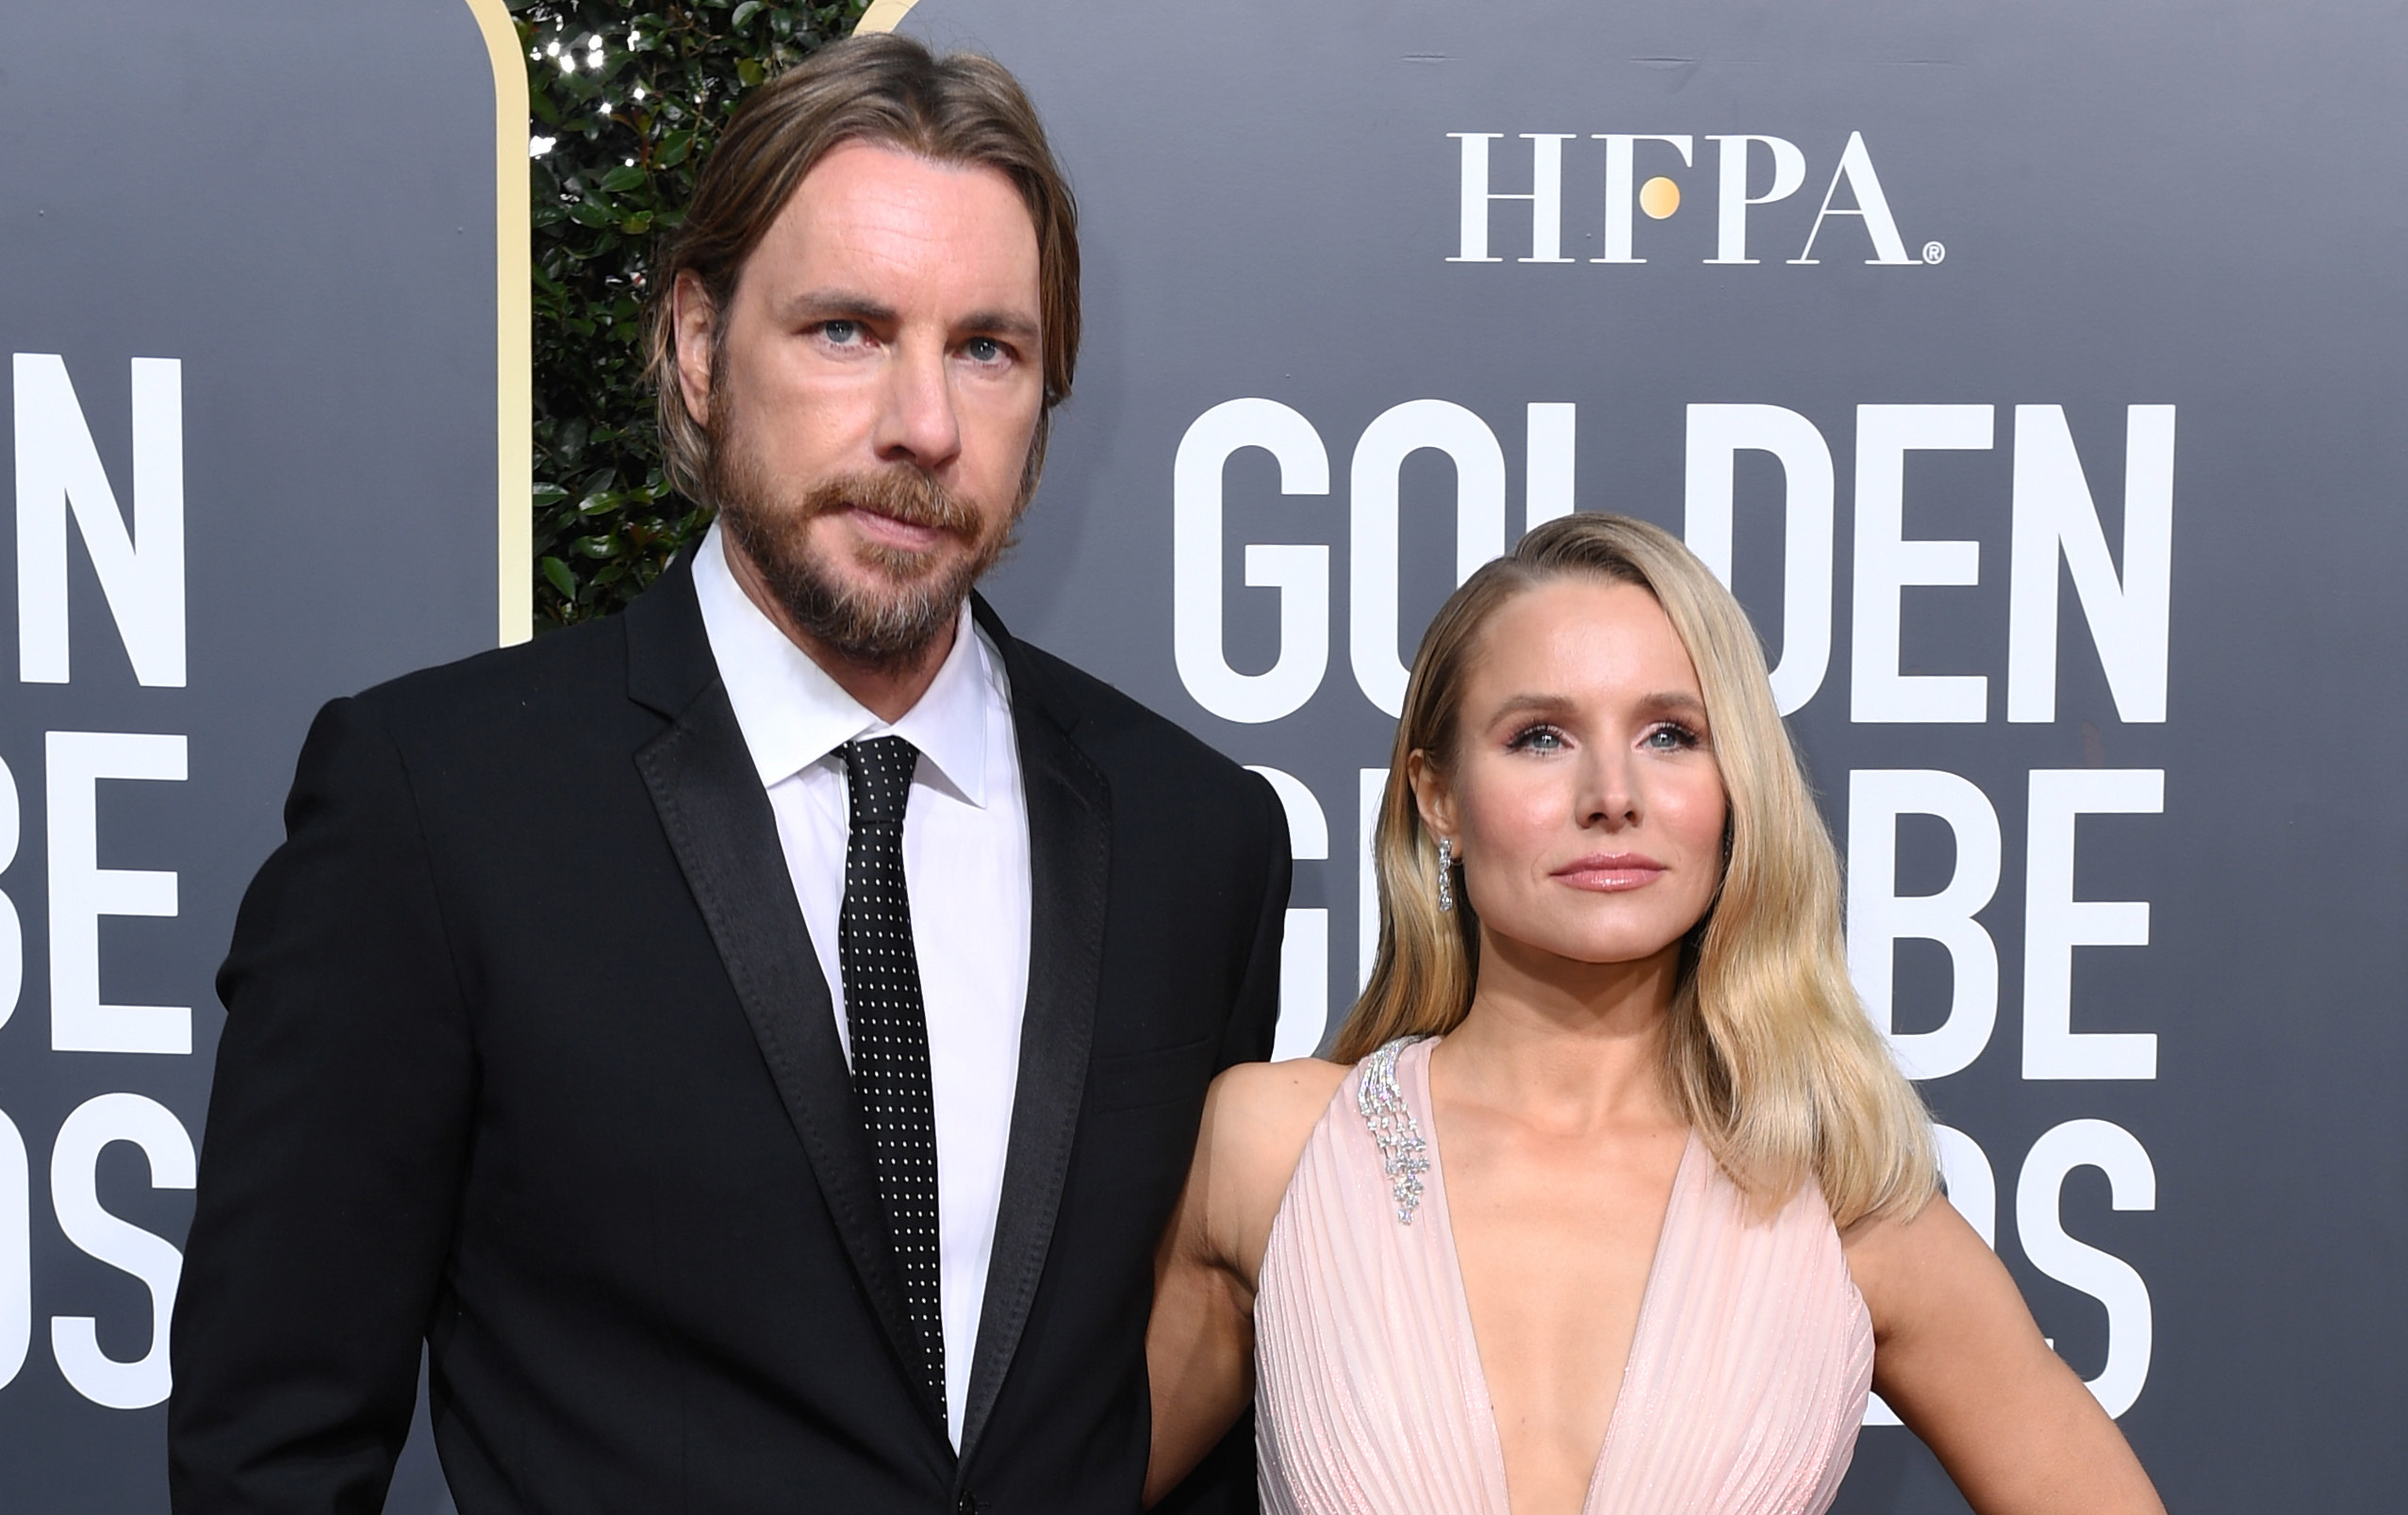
[0,0,527,1515]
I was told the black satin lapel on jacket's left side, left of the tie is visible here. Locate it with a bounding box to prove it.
[631,660,942,1424]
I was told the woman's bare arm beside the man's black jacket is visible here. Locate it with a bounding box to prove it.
[1146,1058,1346,1506]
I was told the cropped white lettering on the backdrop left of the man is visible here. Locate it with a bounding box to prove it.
[0,352,192,1409]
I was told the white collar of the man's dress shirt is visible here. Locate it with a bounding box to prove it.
[694,520,1012,809]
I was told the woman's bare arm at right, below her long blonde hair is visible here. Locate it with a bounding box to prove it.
[1844,1199,2165,1515]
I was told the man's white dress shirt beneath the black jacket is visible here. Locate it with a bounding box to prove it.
[694,522,1029,1447]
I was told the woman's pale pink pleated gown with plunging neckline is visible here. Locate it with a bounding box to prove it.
[1255,1041,1873,1515]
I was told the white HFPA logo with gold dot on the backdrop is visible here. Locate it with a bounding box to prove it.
[1447,133,1948,265]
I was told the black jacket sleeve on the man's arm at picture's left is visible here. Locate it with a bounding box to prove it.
[169,700,474,1515]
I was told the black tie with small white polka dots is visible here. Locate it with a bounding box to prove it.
[835,737,944,1414]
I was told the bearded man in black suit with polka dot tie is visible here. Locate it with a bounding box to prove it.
[169,39,1288,1515]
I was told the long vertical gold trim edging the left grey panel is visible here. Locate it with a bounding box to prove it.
[467,0,535,648]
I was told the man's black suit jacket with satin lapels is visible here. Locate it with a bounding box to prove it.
[169,568,1288,1515]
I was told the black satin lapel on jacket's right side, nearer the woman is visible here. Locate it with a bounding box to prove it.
[961,621,1113,1464]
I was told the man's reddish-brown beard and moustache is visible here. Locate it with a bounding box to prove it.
[705,426,1033,672]
